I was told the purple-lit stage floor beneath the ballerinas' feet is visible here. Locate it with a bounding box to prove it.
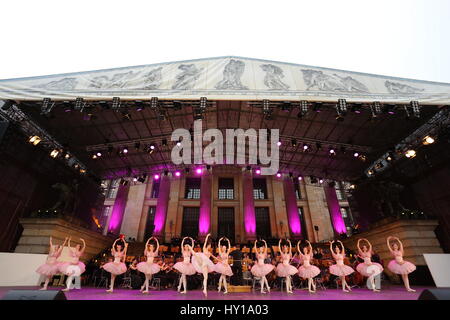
[0,286,428,300]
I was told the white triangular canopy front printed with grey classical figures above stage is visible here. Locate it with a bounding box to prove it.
[0,57,450,105]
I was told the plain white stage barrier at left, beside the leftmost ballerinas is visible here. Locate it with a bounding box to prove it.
[0,252,47,287]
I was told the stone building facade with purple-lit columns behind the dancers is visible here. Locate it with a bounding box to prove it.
[100,166,353,242]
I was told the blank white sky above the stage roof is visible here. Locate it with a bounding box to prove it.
[0,0,450,83]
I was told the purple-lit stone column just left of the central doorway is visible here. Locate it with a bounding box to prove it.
[198,169,212,240]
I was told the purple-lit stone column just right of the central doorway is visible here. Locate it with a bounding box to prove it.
[242,170,256,241]
